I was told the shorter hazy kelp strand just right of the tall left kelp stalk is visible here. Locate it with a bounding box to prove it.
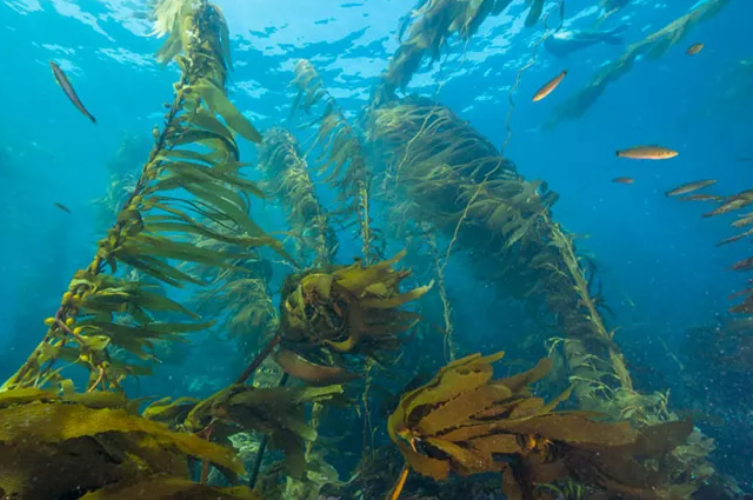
[259,128,337,267]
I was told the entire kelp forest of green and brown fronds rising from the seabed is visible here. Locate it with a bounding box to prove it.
[0,0,753,500]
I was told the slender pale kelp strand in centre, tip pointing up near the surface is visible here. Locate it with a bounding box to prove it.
[292,59,384,262]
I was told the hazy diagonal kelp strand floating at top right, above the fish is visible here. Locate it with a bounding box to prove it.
[546,0,729,127]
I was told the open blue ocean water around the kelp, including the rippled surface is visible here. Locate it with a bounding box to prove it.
[0,0,753,494]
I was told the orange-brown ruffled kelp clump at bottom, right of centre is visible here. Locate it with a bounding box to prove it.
[388,352,693,499]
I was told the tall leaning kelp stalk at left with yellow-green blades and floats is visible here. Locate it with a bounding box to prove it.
[2,0,284,390]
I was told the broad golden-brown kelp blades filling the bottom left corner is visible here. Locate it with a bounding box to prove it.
[0,389,255,499]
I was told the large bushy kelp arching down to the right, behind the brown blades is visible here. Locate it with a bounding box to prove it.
[370,97,705,485]
